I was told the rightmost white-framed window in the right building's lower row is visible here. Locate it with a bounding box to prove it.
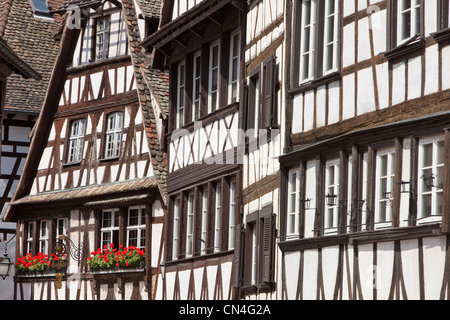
[418,137,444,219]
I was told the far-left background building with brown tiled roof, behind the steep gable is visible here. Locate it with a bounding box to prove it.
[0,0,62,299]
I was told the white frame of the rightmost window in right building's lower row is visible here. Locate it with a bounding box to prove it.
[417,136,444,224]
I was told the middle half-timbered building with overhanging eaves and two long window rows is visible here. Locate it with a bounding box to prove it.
[143,0,246,300]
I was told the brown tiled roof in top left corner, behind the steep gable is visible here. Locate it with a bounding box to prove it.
[0,0,62,113]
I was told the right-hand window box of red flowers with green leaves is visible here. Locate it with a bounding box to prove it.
[87,243,145,270]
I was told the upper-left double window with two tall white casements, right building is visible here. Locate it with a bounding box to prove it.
[294,0,339,84]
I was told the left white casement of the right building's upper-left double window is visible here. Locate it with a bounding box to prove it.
[299,0,317,83]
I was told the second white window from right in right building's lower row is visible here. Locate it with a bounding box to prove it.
[375,150,395,227]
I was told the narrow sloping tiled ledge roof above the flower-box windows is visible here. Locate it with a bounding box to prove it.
[10,177,157,206]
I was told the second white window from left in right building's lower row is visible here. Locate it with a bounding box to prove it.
[324,160,340,233]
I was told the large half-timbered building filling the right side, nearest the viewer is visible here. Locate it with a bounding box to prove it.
[279,0,450,300]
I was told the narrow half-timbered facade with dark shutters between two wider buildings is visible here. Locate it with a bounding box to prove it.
[234,0,285,300]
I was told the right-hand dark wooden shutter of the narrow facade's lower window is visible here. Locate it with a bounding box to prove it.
[260,206,275,283]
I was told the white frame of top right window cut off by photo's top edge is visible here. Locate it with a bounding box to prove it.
[397,0,421,45]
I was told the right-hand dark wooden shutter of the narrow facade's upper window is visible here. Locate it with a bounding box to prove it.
[262,55,275,128]
